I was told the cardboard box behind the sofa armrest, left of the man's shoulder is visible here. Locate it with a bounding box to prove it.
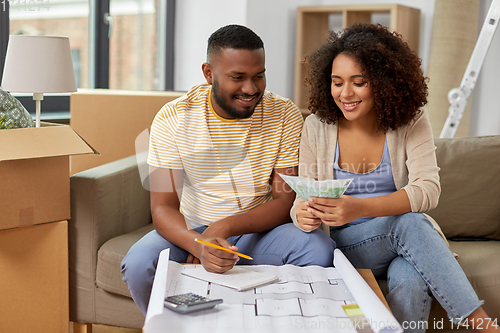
[70,89,185,174]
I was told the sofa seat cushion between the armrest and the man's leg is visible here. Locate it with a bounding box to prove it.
[96,223,153,297]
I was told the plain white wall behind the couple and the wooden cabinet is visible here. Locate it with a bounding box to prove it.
[174,0,500,135]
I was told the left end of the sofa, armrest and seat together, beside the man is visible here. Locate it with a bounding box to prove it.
[69,156,153,331]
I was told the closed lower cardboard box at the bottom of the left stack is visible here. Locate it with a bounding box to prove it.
[0,221,69,333]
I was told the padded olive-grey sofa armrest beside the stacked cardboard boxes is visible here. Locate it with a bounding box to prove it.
[69,155,151,322]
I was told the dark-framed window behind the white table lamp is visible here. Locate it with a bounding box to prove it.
[0,0,175,122]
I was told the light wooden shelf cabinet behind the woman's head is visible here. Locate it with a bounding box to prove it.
[294,4,420,114]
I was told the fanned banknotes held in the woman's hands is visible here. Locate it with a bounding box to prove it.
[279,174,353,201]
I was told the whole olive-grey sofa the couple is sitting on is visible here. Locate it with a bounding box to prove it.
[69,136,500,328]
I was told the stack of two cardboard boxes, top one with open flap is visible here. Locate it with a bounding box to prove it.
[0,124,95,332]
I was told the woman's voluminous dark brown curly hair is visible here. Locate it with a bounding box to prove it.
[304,23,428,132]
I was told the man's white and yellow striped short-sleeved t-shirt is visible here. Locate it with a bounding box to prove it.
[148,84,303,226]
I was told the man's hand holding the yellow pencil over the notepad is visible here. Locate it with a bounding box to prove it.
[194,237,239,273]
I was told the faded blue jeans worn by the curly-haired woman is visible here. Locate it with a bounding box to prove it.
[330,213,482,332]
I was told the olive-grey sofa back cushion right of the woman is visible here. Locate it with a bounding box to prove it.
[428,136,500,240]
